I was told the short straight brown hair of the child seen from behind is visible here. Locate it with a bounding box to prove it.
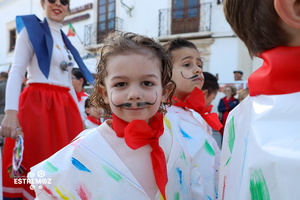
[224,0,291,56]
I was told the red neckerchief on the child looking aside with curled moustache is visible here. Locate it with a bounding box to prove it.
[173,87,223,131]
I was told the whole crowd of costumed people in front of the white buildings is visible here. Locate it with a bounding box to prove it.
[0,0,300,200]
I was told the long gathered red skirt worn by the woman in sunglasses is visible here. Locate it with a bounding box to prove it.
[2,83,83,199]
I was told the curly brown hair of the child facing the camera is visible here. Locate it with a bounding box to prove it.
[91,31,175,115]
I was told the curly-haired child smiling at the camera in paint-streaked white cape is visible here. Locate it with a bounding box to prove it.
[28,32,202,200]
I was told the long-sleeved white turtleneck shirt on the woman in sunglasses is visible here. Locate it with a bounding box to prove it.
[5,19,77,110]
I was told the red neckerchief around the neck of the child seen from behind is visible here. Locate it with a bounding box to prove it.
[248,46,300,96]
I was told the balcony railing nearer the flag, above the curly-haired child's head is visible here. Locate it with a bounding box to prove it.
[84,17,123,47]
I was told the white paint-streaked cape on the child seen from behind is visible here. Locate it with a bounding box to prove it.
[219,92,300,200]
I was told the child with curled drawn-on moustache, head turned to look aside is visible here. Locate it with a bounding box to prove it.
[164,38,221,199]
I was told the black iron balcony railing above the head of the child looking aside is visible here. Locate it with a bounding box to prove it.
[158,2,212,36]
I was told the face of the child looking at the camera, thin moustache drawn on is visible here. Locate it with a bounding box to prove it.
[102,53,165,122]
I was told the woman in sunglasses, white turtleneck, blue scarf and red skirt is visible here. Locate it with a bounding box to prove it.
[1,0,93,199]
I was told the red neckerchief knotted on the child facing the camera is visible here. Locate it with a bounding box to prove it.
[112,112,168,199]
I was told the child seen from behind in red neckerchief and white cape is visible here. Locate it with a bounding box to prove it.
[219,0,300,200]
